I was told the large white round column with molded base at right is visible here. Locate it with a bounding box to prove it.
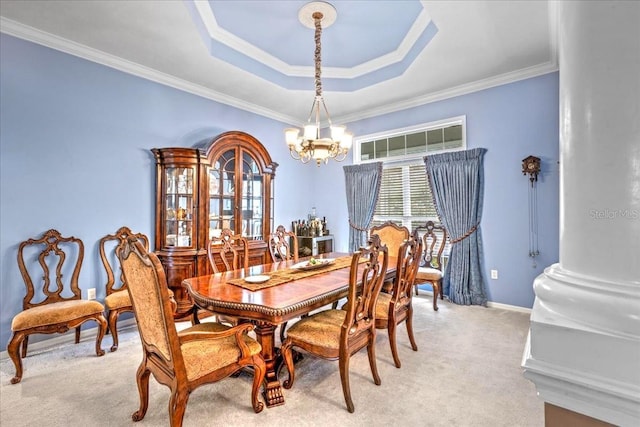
[523,1,640,426]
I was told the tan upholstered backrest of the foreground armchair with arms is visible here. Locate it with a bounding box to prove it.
[118,236,186,380]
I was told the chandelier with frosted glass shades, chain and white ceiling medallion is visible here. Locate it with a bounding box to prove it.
[284,2,353,166]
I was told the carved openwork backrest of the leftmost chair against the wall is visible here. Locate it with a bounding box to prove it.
[18,229,84,310]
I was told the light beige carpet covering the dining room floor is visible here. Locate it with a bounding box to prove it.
[0,294,544,427]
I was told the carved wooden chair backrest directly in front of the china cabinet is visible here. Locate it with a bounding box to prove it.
[207,228,249,273]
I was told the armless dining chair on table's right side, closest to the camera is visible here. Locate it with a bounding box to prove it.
[281,234,389,412]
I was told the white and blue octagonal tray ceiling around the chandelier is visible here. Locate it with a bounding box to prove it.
[0,0,557,124]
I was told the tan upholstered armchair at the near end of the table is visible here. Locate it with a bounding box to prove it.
[118,237,266,427]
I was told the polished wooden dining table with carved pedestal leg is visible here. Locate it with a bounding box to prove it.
[182,252,395,407]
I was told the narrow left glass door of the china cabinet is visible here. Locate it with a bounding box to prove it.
[164,167,196,247]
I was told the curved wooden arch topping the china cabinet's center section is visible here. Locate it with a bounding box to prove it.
[206,131,278,176]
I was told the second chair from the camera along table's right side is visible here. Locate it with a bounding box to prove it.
[376,233,422,368]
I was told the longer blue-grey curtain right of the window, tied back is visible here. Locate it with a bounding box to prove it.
[424,148,487,305]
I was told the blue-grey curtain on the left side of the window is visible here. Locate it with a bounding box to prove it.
[344,162,382,252]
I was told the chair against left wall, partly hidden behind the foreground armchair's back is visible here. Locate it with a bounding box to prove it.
[98,227,149,351]
